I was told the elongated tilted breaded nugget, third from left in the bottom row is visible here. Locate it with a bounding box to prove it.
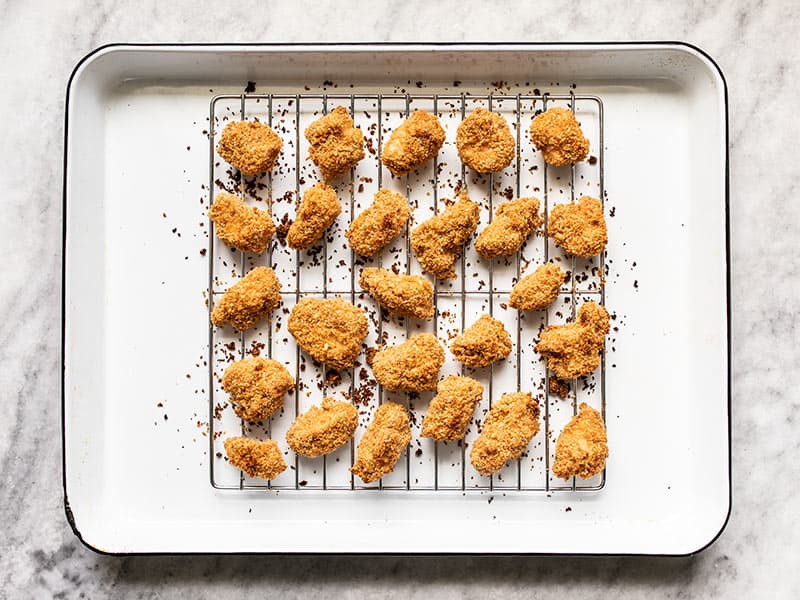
[350,402,411,483]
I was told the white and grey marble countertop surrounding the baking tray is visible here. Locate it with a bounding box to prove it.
[0,0,800,600]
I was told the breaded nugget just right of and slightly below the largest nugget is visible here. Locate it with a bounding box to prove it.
[372,333,444,392]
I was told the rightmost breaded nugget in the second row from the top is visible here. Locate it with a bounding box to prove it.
[547,196,608,258]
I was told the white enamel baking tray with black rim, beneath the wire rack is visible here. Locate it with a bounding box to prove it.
[62,43,731,555]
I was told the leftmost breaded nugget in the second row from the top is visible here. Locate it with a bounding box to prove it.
[208,192,275,254]
